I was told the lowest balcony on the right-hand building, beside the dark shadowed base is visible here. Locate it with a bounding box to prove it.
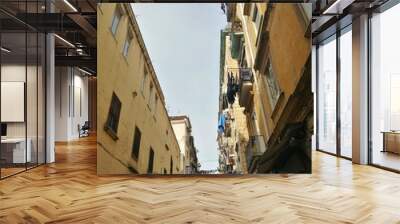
[246,135,266,173]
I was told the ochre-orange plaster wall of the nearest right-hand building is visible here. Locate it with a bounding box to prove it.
[259,4,311,138]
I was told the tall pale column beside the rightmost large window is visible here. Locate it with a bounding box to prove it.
[352,15,368,164]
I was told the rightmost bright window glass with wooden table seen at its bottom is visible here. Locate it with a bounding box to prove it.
[370,4,400,170]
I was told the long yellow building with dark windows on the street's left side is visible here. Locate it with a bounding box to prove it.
[97,4,182,174]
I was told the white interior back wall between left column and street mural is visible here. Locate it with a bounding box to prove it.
[55,67,89,141]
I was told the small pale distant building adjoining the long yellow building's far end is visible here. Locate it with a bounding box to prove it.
[170,116,199,174]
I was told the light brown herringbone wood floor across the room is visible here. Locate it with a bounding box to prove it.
[0,138,400,224]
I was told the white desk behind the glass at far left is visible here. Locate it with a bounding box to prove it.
[1,138,32,163]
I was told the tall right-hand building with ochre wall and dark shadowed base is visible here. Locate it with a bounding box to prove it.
[220,3,313,173]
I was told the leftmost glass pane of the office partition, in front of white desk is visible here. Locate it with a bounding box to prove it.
[0,32,27,177]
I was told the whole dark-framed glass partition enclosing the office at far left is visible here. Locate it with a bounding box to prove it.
[0,1,46,178]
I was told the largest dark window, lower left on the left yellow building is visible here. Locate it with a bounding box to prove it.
[104,93,121,139]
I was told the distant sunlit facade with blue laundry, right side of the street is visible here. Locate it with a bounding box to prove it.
[217,26,249,174]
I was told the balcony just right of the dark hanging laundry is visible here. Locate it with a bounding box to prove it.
[238,68,254,110]
